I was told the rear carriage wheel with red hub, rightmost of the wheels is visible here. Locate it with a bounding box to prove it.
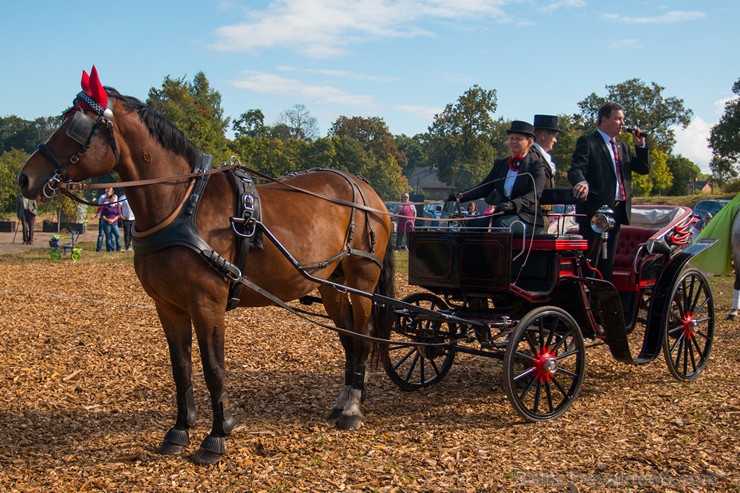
[663,269,714,381]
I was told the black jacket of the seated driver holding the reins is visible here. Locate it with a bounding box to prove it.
[460,150,548,226]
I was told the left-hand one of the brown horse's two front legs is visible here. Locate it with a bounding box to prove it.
[157,304,198,455]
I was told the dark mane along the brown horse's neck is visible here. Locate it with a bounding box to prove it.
[105,86,199,167]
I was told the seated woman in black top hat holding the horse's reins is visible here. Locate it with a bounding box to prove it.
[448,120,548,234]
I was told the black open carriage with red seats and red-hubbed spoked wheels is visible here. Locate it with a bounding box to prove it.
[386,190,714,421]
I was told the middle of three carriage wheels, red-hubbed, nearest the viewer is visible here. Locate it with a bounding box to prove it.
[504,306,586,421]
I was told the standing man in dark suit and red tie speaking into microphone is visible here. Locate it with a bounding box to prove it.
[568,103,650,281]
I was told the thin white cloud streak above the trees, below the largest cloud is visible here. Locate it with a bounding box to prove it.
[231,71,377,108]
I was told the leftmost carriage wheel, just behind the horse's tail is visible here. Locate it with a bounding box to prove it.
[385,293,456,390]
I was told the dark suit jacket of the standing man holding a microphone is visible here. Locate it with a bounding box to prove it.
[568,131,650,224]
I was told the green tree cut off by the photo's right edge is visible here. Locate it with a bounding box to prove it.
[709,79,740,181]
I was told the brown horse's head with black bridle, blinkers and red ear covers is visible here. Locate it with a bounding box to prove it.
[18,67,119,198]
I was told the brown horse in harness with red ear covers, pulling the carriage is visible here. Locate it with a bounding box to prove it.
[18,67,393,464]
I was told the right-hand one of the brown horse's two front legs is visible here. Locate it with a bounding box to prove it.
[192,310,234,465]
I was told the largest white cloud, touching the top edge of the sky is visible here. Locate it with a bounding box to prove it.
[205,0,511,58]
